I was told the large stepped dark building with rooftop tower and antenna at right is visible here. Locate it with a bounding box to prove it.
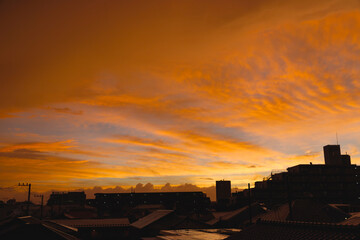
[252,145,360,203]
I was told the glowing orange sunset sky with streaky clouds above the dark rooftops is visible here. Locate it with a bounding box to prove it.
[0,0,360,200]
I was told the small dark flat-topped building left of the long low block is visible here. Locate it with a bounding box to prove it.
[47,192,86,206]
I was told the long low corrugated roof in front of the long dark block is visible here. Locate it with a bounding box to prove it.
[51,218,130,228]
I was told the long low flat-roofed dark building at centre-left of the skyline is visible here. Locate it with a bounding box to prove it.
[95,192,210,216]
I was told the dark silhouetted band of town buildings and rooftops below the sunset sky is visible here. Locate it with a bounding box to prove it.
[0,145,360,240]
